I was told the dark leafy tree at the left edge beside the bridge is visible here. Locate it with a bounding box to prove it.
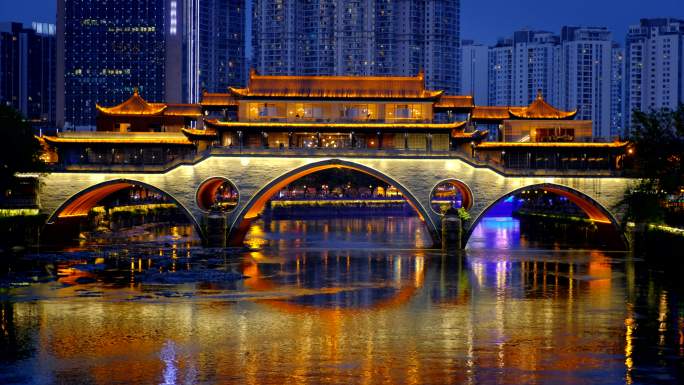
[0,105,45,194]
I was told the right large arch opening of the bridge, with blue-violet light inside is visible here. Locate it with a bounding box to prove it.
[464,183,628,250]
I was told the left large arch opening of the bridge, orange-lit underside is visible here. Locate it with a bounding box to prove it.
[43,179,204,244]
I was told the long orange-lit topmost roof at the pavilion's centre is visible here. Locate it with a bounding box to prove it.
[230,70,443,99]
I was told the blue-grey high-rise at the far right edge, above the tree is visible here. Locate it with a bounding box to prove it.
[624,18,684,129]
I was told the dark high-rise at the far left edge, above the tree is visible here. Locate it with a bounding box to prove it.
[0,23,56,125]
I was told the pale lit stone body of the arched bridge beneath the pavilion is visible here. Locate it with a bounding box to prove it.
[40,153,629,248]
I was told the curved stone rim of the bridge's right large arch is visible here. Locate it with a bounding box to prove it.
[463,183,629,247]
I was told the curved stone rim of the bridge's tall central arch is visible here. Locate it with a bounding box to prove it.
[229,159,440,245]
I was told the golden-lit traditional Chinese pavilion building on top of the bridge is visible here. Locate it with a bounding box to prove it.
[43,71,624,168]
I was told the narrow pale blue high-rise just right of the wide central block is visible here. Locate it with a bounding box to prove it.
[460,40,489,106]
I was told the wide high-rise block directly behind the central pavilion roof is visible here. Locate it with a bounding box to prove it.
[252,0,460,93]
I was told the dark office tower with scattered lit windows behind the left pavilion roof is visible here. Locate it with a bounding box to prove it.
[57,0,182,130]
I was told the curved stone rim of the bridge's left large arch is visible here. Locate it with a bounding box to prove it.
[46,178,204,240]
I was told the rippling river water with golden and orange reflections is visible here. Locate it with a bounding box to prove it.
[0,214,684,384]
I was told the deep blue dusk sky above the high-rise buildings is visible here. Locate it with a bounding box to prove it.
[0,0,684,44]
